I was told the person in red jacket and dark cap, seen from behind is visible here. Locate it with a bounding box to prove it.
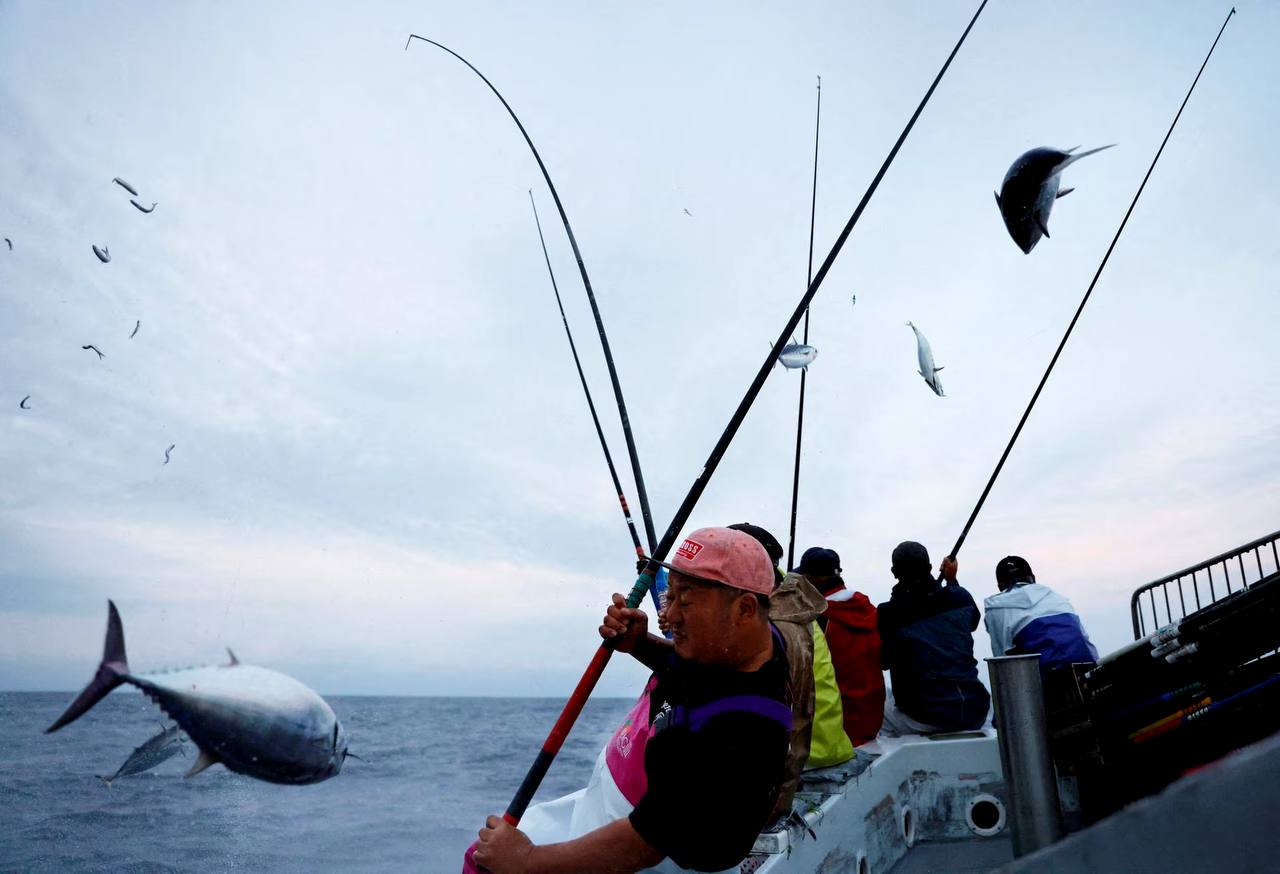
[796,546,884,746]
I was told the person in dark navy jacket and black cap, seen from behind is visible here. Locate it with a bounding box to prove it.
[877,540,991,736]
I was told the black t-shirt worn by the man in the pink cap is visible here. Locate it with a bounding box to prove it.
[630,635,791,871]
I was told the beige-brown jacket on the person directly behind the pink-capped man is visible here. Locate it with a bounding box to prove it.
[769,573,827,822]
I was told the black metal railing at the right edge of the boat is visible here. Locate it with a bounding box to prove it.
[1129,531,1280,640]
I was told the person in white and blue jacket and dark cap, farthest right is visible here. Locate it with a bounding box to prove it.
[982,555,1098,676]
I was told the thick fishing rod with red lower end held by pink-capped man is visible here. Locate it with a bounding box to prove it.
[502,0,988,825]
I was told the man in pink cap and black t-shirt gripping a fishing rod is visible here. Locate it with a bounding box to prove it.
[474,528,791,874]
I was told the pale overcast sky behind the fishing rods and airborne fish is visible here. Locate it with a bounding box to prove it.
[0,0,1280,696]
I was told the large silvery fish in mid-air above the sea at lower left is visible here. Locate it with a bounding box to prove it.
[45,601,347,786]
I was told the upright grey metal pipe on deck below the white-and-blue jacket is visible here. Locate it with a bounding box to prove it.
[987,654,1062,857]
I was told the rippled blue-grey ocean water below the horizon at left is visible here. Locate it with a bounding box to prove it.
[0,690,634,874]
